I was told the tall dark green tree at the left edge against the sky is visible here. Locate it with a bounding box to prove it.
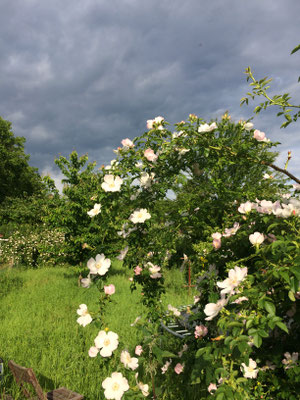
[0,117,43,204]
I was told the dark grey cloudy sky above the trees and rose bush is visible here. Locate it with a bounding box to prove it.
[0,0,300,191]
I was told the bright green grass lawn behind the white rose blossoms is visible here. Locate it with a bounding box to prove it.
[0,262,197,400]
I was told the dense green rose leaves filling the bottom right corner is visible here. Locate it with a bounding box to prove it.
[186,208,300,399]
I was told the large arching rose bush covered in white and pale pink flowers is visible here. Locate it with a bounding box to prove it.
[75,114,300,400]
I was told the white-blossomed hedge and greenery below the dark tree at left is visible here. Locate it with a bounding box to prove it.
[0,170,65,267]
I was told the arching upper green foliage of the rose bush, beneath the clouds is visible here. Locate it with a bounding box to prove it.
[81,116,284,280]
